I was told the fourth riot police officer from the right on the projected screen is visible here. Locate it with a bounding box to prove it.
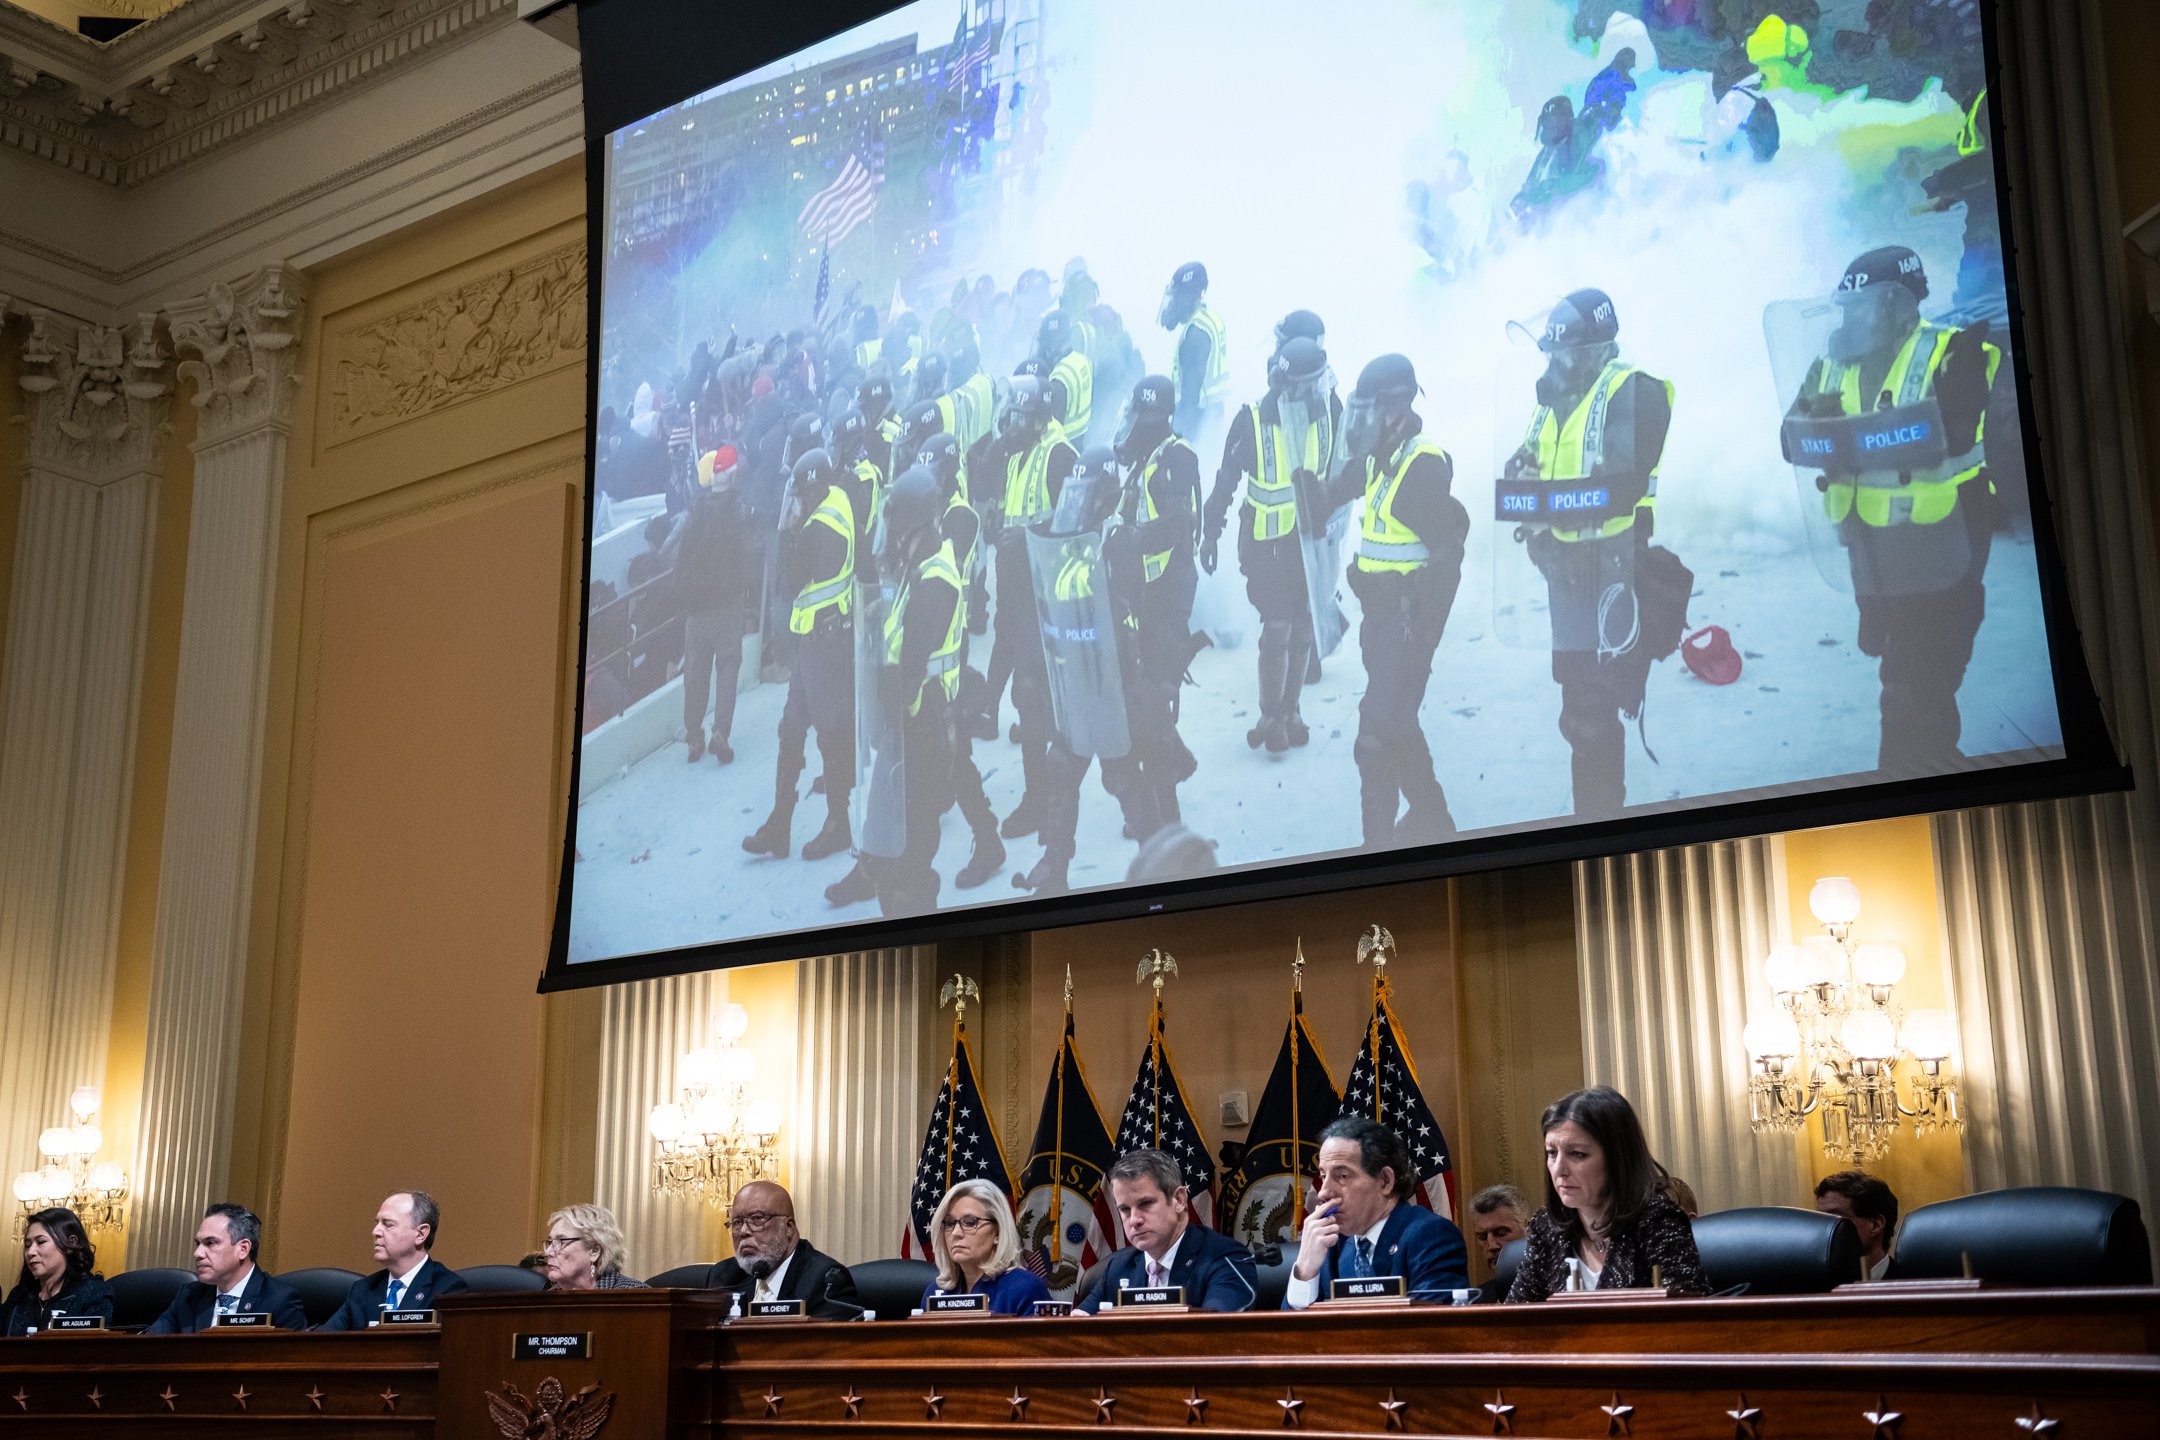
[1201,334,1341,756]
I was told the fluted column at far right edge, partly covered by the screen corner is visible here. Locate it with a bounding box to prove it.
[1933,0,2160,1243]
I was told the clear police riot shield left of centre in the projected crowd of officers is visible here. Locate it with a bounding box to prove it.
[1028,527,1132,760]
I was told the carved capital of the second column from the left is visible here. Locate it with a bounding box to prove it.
[166,263,307,447]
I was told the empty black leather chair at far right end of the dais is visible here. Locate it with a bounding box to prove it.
[1886,1185,2154,1287]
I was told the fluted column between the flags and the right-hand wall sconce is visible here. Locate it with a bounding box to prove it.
[1575,840,1808,1211]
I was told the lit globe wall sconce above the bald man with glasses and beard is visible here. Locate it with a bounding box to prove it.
[646,1004,780,1209]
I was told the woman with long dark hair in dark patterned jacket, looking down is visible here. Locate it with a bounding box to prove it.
[1508,1086,1709,1304]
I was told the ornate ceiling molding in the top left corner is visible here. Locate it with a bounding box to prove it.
[0,0,518,190]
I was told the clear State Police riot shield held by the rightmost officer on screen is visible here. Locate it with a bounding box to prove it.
[1763,285,1972,596]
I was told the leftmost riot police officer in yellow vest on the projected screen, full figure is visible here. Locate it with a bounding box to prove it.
[743,449,858,859]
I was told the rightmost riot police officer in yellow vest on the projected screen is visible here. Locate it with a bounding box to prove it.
[1786,246,2015,777]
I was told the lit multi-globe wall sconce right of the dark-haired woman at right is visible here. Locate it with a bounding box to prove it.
[1743,877,1966,1166]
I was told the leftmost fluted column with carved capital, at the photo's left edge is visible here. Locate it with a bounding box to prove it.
[0,302,171,1200]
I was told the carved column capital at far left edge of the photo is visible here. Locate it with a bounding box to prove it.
[13,302,173,484]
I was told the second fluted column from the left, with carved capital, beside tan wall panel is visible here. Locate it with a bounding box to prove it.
[130,266,302,1256]
